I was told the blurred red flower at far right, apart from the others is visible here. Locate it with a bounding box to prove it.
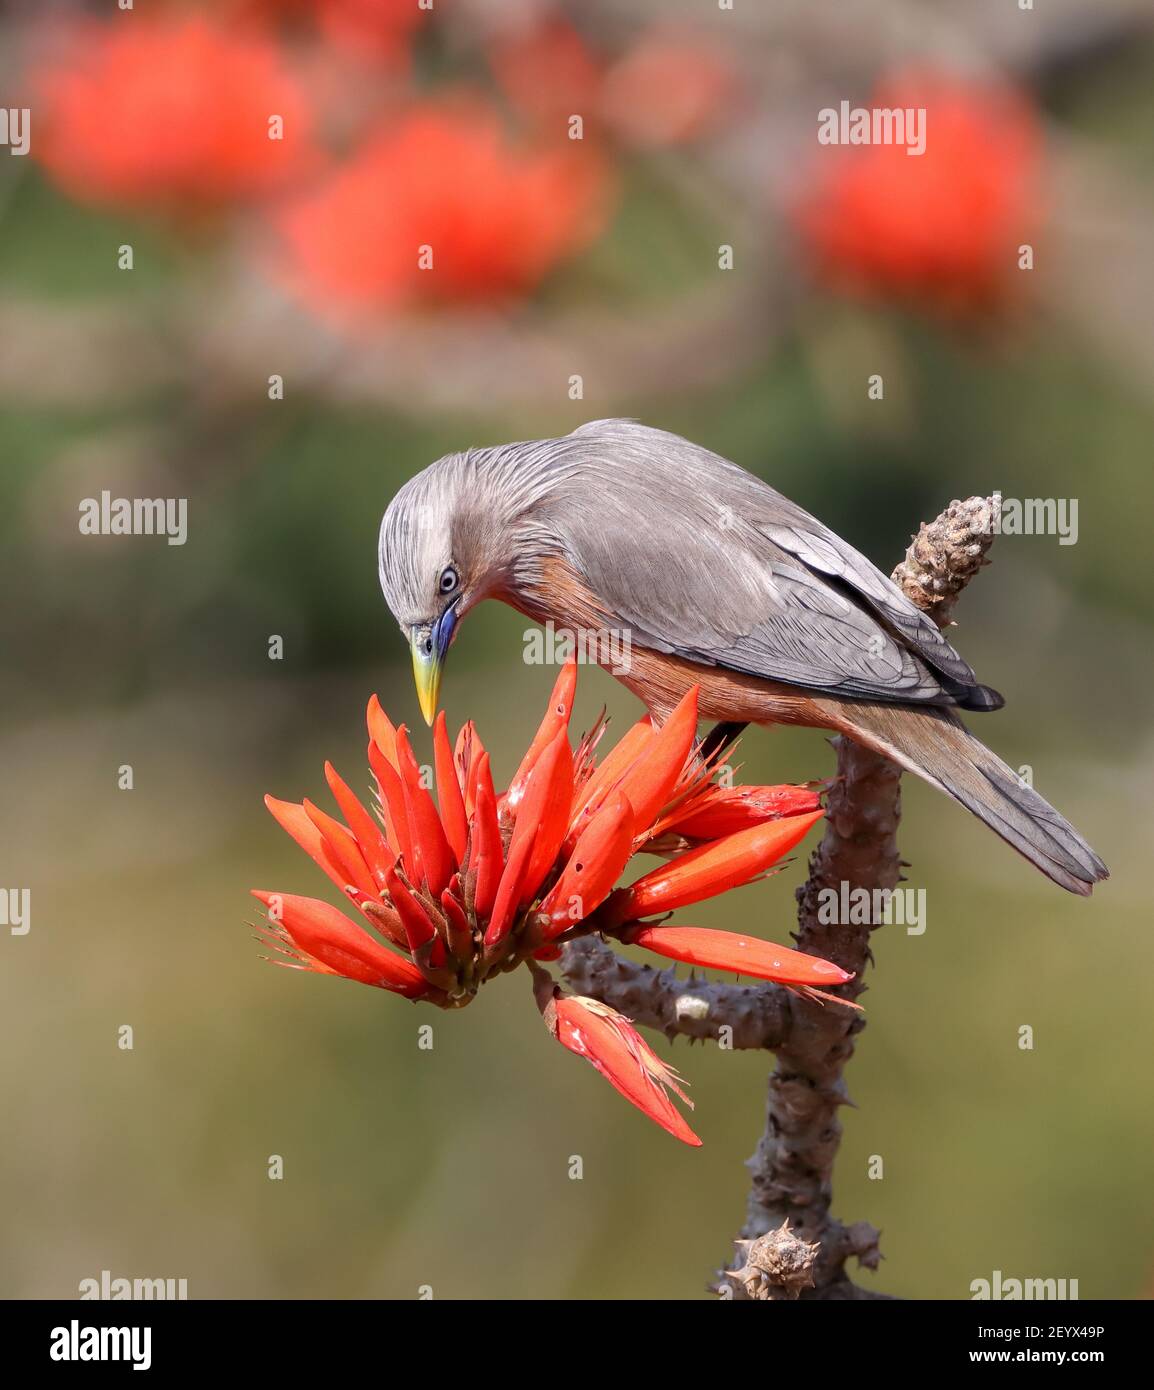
[795,72,1041,311]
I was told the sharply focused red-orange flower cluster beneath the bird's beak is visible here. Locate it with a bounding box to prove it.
[256,662,851,1143]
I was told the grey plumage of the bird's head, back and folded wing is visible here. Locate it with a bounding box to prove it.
[380,420,1001,709]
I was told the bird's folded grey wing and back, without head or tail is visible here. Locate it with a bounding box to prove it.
[564,421,997,705]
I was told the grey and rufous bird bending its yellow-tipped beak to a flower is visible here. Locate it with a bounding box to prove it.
[378,420,1108,895]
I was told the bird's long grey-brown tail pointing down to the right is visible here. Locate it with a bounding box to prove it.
[829,701,1110,895]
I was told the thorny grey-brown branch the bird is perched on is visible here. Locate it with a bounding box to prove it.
[563,496,1000,1300]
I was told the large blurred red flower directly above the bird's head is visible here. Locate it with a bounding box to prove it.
[278,101,608,320]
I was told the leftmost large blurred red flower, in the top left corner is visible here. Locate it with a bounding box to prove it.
[31,15,316,213]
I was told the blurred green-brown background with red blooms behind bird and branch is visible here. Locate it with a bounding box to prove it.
[0,0,1154,1298]
